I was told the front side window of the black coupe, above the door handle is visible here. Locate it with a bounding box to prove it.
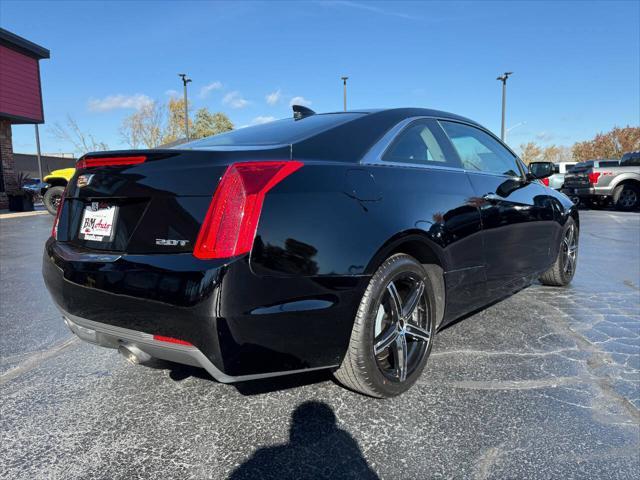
[440,121,521,177]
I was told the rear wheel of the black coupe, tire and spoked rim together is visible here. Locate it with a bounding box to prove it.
[334,254,436,398]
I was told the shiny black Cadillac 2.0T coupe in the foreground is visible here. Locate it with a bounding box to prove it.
[43,107,579,397]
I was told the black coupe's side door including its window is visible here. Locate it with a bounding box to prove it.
[440,120,555,299]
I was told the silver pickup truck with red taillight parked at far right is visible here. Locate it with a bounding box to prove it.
[562,156,640,211]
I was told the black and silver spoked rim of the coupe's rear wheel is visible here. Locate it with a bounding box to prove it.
[373,273,432,382]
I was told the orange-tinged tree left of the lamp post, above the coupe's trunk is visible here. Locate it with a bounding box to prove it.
[120,102,165,148]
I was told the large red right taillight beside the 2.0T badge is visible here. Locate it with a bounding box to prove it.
[193,161,303,259]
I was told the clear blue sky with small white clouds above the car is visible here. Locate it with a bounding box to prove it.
[0,0,640,156]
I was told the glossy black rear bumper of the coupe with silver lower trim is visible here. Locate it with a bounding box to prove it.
[43,239,368,382]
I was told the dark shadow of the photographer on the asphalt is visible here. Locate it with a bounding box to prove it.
[229,401,378,480]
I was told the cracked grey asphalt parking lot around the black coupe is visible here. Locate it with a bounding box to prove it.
[0,211,640,480]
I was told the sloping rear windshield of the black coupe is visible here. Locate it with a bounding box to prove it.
[184,113,365,149]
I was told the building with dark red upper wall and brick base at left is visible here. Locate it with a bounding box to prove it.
[0,28,49,209]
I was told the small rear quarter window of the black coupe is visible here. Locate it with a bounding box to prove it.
[382,120,460,168]
